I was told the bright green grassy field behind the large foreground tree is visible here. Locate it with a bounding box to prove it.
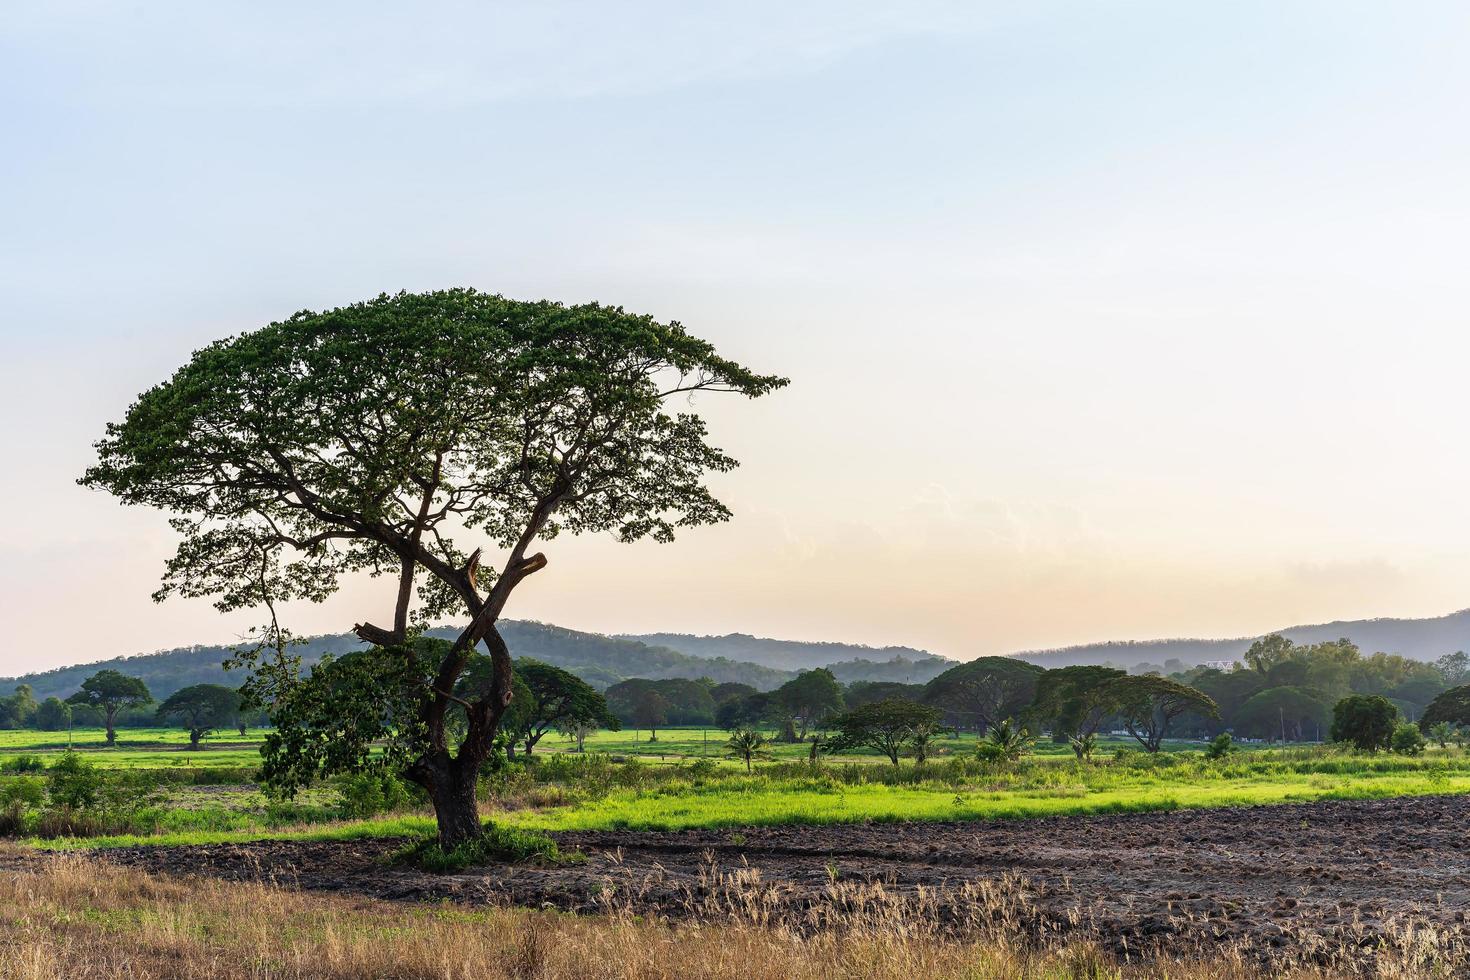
[11,719,1470,848]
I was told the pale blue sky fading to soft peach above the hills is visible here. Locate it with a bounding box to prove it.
[0,0,1470,673]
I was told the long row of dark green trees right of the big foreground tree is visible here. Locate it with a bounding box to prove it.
[635,635,1470,763]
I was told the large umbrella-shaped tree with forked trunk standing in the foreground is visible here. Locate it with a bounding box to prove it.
[81,289,785,846]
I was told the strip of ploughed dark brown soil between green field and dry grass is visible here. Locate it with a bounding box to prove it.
[31,796,1470,962]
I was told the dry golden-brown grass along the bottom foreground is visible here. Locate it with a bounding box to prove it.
[0,855,1452,980]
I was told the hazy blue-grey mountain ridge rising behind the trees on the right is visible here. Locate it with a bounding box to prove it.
[1013,608,1470,667]
